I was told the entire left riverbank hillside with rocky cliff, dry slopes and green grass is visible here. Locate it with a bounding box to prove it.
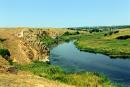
[0,28,114,87]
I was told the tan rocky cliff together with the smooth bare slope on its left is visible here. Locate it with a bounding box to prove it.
[0,28,63,63]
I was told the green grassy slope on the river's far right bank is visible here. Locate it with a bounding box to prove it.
[75,29,130,57]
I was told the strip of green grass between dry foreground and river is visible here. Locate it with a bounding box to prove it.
[15,61,114,87]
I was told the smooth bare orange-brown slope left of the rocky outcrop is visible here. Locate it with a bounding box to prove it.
[0,29,29,62]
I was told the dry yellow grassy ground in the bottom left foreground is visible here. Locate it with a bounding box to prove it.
[0,72,74,87]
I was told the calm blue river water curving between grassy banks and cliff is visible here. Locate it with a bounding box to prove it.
[50,41,130,85]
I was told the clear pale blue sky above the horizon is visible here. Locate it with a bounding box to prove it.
[0,0,130,27]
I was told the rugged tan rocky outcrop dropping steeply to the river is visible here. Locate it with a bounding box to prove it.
[15,29,63,61]
